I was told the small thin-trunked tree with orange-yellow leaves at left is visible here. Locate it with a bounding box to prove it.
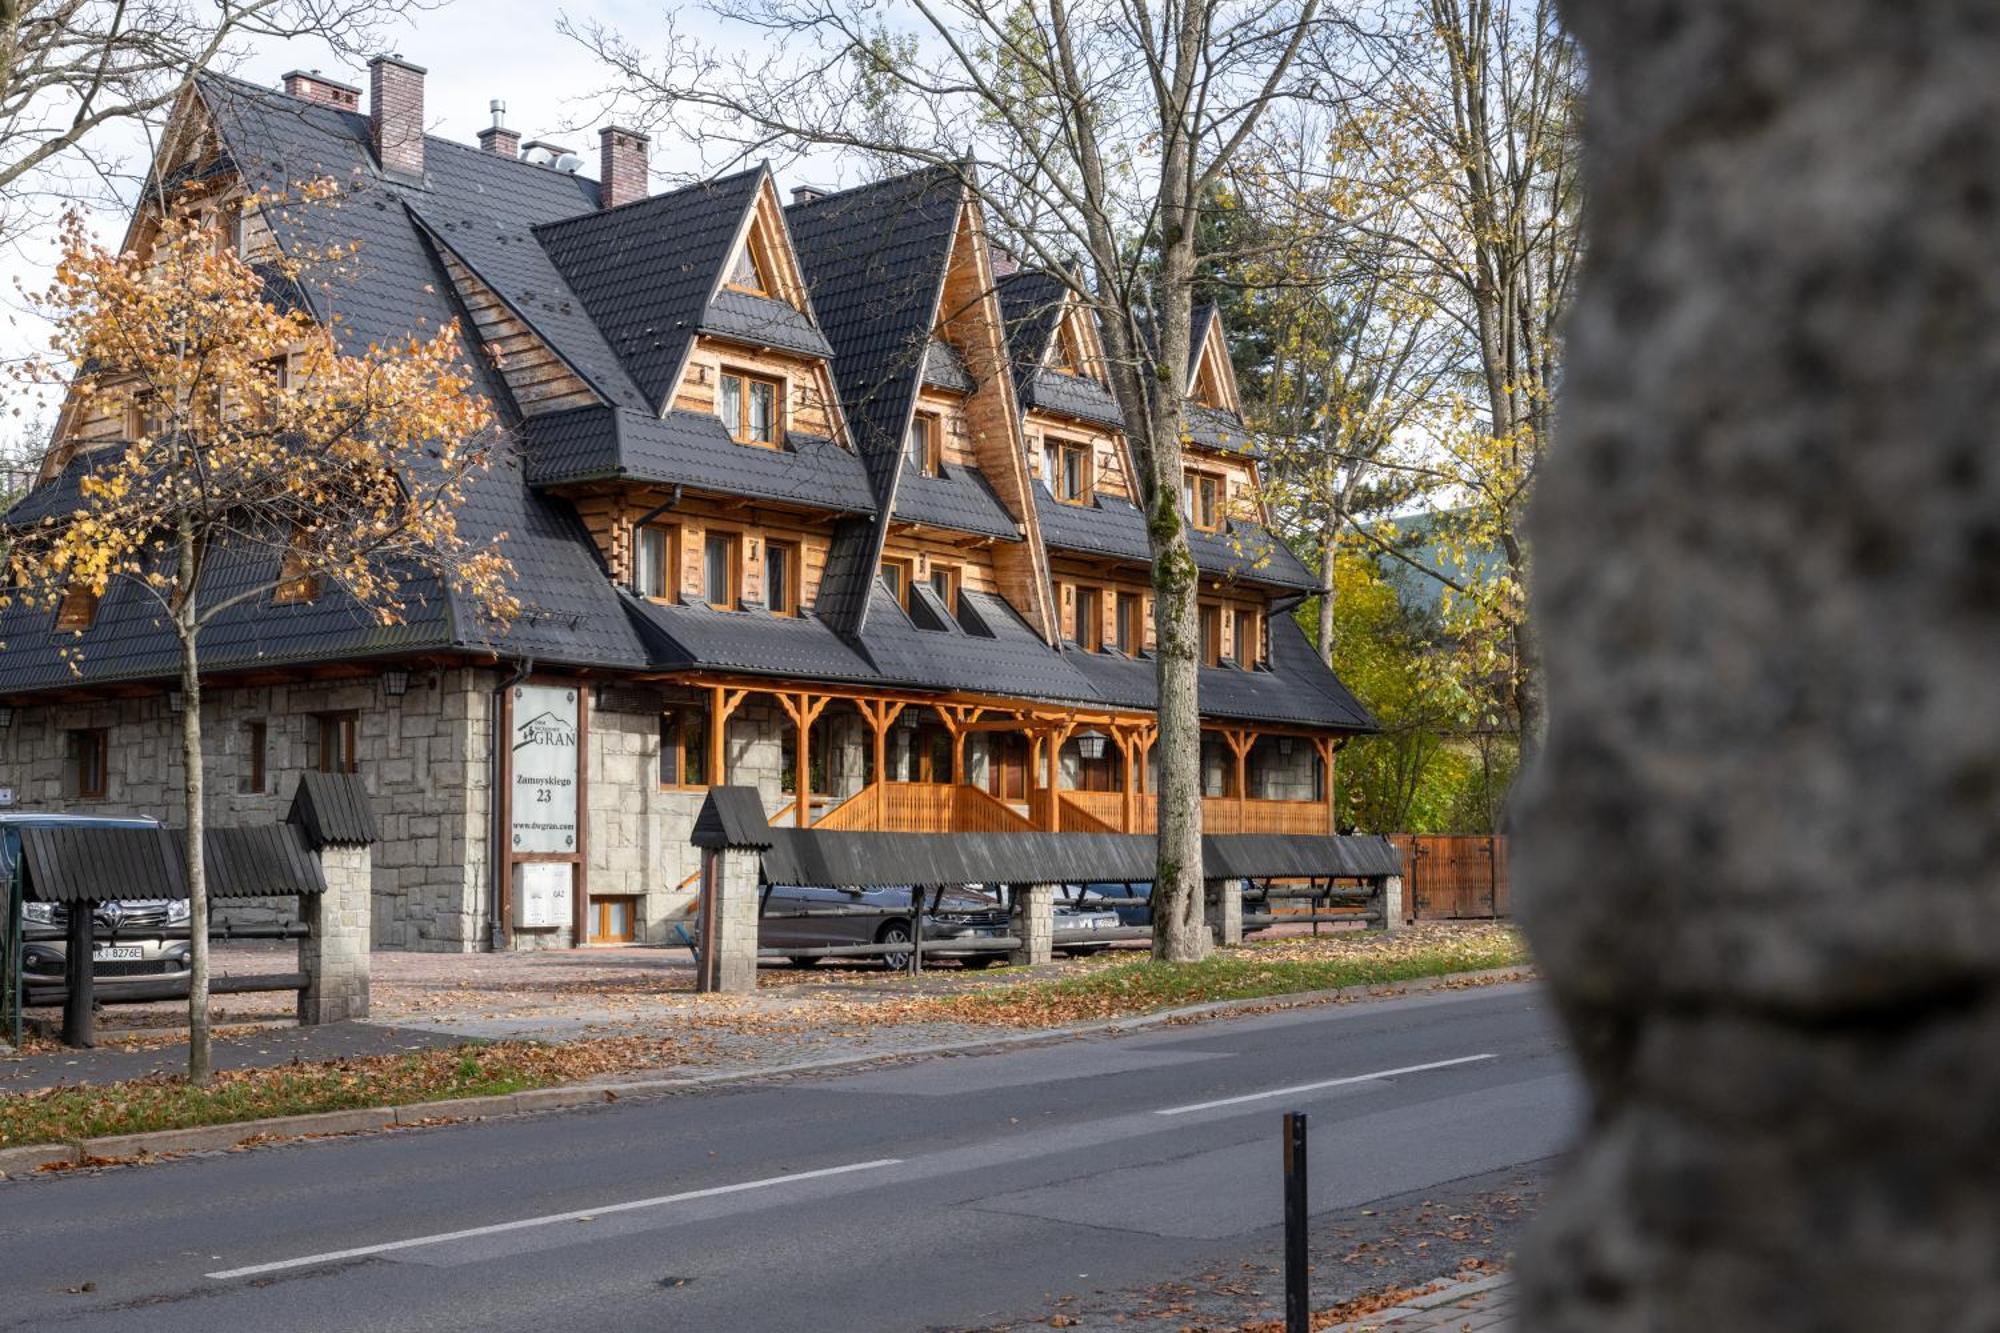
[6,197,518,1083]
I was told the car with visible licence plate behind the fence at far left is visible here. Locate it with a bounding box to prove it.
[0,811,192,981]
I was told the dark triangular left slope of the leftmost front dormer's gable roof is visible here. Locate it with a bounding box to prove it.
[534,166,768,412]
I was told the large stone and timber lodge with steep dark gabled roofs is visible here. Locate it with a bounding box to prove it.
[0,58,1372,951]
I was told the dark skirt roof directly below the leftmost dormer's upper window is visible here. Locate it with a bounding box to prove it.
[520,406,874,514]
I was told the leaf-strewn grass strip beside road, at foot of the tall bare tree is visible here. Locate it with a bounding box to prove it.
[936,927,1528,1027]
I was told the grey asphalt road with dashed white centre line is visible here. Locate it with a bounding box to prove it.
[0,987,1580,1333]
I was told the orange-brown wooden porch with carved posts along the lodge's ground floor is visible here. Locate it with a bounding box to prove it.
[676,681,1340,835]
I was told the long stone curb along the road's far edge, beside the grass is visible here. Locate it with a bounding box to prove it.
[0,965,1534,1179]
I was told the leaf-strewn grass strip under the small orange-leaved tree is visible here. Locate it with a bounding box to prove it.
[0,1039,674,1147]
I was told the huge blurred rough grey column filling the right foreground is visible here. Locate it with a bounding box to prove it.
[1514,0,2000,1333]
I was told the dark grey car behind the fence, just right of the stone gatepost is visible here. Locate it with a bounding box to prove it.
[758,885,1008,971]
